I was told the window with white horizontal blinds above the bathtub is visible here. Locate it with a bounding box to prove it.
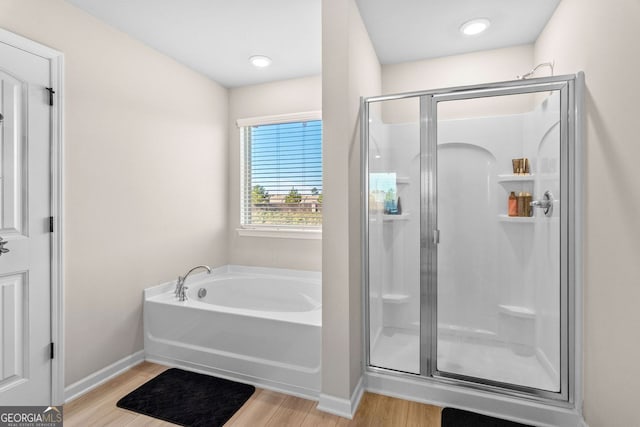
[238,113,322,231]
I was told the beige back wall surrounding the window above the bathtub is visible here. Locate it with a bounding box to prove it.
[228,76,322,271]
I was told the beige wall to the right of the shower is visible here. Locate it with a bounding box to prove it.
[535,0,640,427]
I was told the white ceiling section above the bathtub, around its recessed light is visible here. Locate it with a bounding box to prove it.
[67,0,322,87]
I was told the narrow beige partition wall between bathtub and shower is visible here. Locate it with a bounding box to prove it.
[321,0,381,403]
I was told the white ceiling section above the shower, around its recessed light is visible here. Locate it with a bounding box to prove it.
[356,0,560,64]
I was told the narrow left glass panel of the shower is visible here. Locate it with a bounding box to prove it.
[366,98,420,374]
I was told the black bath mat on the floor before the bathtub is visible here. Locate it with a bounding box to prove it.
[116,368,256,427]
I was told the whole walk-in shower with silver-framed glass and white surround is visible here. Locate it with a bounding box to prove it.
[362,75,581,422]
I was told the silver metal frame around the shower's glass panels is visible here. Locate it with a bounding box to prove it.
[360,72,584,408]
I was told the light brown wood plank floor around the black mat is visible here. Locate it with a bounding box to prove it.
[63,362,441,427]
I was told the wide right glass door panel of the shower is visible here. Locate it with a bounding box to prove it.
[434,90,561,392]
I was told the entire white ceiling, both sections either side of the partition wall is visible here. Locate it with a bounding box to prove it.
[67,0,560,87]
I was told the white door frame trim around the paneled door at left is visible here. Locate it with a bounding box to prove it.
[0,28,64,405]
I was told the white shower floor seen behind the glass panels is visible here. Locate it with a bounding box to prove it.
[371,328,559,391]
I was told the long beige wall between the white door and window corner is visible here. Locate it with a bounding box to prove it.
[0,0,228,385]
